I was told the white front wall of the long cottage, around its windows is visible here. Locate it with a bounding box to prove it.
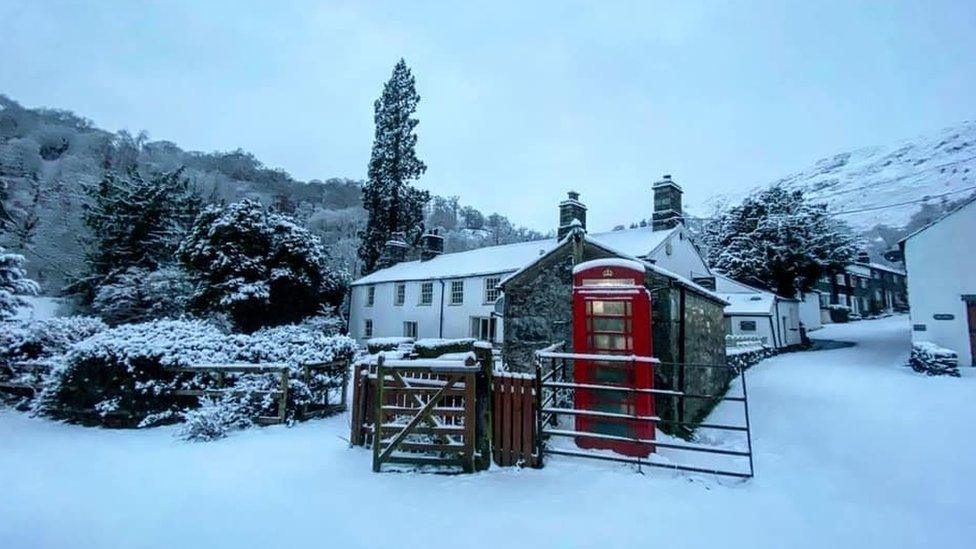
[349,274,505,343]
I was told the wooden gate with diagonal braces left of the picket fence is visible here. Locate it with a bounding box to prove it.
[371,356,479,472]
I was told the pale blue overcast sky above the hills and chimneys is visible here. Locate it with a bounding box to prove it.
[0,0,976,230]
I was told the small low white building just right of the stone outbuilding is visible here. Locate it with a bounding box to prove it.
[715,275,801,349]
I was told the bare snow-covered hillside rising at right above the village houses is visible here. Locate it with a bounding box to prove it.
[701,121,976,231]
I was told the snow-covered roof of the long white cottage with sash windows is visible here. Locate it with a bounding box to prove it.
[352,227,679,286]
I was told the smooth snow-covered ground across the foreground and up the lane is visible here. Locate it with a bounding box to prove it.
[0,317,976,549]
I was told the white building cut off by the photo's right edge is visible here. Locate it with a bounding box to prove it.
[900,196,976,366]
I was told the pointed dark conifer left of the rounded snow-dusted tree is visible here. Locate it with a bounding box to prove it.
[84,168,200,285]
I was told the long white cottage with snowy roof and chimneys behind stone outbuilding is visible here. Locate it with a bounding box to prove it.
[349,176,711,343]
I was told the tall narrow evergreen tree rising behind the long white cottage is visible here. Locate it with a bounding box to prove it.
[358,59,430,273]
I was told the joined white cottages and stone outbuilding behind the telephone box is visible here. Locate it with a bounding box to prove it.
[350,175,819,372]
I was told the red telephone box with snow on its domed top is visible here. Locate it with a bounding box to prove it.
[573,259,655,457]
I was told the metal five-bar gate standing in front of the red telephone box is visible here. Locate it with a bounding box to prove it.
[535,345,754,478]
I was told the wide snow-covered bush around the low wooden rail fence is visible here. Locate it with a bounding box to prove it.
[34,320,356,440]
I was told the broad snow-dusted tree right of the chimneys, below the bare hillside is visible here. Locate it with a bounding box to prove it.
[702,186,857,297]
